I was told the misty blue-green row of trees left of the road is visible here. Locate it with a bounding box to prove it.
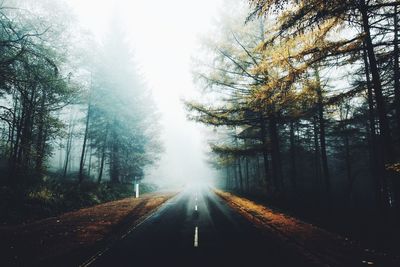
[0,0,160,224]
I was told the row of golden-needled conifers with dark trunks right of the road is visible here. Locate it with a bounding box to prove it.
[186,0,400,225]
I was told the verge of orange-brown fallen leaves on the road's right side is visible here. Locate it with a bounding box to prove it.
[214,189,400,266]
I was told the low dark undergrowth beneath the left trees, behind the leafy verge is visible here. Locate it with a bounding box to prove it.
[0,179,157,224]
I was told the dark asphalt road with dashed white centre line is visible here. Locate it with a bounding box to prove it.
[90,187,314,267]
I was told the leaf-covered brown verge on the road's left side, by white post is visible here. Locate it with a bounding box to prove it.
[0,192,176,266]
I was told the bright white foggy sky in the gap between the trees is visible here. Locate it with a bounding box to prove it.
[67,0,222,186]
